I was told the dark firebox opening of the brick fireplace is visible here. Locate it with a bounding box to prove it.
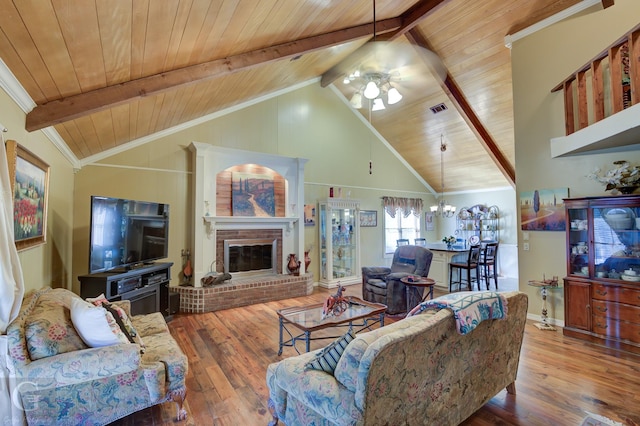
[224,238,278,276]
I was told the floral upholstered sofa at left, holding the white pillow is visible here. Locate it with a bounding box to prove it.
[7,288,188,425]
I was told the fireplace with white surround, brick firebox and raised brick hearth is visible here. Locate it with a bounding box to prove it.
[178,142,314,312]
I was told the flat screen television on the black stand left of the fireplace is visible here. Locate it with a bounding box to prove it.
[89,195,169,273]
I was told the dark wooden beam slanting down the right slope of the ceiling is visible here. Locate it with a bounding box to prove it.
[405,28,516,188]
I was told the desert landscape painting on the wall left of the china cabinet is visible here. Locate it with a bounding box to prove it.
[520,188,569,231]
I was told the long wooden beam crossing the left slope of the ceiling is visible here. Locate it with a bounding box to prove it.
[25,18,401,132]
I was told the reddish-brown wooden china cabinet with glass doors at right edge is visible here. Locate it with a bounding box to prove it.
[563,195,640,353]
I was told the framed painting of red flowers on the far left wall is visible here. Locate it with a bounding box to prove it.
[6,140,49,250]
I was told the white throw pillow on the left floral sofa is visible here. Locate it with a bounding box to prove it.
[71,299,129,348]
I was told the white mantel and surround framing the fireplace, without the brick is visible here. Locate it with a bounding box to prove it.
[189,142,308,287]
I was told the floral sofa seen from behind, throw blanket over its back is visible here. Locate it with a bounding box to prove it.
[267,292,528,426]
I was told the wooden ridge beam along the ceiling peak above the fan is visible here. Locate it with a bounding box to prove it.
[320,0,450,87]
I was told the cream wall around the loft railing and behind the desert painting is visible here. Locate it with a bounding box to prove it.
[511,0,640,321]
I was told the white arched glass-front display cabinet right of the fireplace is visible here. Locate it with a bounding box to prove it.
[318,198,361,288]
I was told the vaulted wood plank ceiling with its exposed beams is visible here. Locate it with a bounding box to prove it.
[0,0,600,191]
